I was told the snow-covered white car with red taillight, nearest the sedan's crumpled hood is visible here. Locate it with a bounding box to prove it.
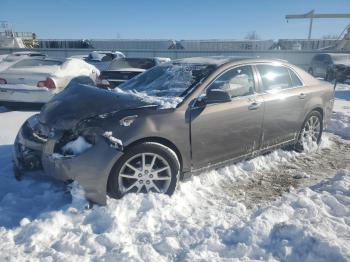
[0,58,100,105]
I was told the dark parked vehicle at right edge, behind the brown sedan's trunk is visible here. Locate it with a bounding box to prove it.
[308,53,350,82]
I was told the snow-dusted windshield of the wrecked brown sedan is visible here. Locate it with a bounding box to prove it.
[119,63,215,97]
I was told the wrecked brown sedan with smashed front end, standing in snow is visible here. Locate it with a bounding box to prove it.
[14,58,334,204]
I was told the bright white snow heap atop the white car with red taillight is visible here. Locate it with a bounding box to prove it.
[52,58,100,78]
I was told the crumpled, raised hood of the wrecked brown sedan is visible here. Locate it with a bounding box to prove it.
[39,84,151,130]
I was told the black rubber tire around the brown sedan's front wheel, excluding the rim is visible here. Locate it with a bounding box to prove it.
[107,142,180,199]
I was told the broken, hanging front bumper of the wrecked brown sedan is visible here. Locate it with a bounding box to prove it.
[14,116,122,205]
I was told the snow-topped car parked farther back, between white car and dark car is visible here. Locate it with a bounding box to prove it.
[72,51,125,71]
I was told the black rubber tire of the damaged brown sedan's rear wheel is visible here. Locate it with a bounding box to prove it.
[295,111,323,152]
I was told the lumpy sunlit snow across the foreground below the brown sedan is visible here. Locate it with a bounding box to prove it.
[0,151,350,261]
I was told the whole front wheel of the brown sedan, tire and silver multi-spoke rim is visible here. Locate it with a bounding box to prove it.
[107,142,180,199]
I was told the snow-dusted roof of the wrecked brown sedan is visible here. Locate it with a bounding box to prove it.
[171,56,288,66]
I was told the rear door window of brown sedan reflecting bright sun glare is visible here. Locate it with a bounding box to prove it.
[257,65,293,91]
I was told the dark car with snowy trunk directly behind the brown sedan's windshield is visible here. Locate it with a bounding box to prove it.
[97,58,161,89]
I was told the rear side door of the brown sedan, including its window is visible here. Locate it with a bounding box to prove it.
[256,64,307,149]
